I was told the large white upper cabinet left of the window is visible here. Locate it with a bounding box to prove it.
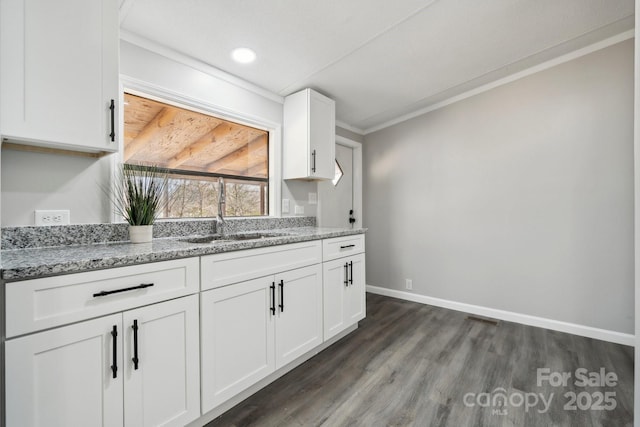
[0,0,119,152]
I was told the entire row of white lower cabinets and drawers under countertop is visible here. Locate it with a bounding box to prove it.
[0,236,365,427]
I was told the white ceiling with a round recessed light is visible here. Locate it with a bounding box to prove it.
[121,0,634,131]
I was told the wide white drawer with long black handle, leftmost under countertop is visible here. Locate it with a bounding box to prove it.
[5,258,199,338]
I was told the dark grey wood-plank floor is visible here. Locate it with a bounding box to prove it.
[208,294,634,427]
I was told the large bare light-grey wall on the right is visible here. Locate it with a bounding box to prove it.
[363,40,634,333]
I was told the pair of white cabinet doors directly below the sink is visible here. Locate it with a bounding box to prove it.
[201,264,322,413]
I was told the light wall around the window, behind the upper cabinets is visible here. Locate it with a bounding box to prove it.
[0,41,317,226]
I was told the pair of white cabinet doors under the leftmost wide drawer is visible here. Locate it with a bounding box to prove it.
[5,295,200,427]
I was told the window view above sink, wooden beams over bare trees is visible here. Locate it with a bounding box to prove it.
[124,93,269,218]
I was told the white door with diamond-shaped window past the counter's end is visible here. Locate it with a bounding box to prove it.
[318,144,359,228]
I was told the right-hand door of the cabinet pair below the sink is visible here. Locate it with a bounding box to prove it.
[275,264,322,369]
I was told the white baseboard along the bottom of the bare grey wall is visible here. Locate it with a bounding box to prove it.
[367,285,636,347]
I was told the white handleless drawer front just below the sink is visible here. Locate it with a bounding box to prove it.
[200,240,322,291]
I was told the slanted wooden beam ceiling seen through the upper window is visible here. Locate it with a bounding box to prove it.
[124,93,269,178]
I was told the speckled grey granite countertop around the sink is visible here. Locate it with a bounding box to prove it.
[0,227,365,281]
